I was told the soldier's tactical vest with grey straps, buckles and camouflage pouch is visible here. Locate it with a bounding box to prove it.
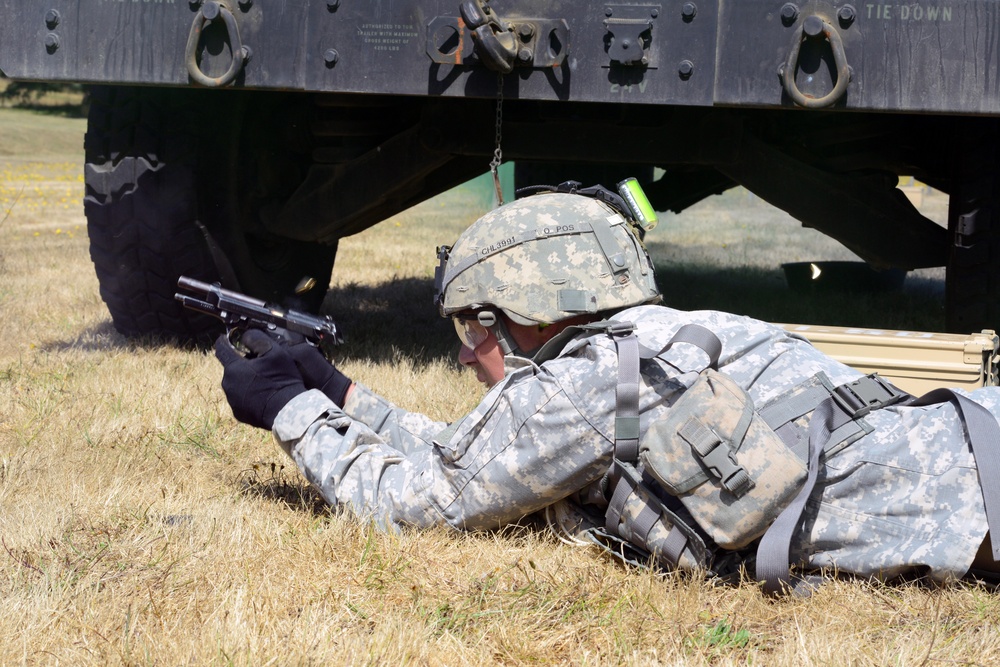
[553,321,1000,594]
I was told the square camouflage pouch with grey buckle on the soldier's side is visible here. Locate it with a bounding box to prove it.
[639,368,807,549]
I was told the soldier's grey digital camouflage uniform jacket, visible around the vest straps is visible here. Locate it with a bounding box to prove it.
[274,306,1000,580]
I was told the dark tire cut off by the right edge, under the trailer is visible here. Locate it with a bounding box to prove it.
[945,118,1000,333]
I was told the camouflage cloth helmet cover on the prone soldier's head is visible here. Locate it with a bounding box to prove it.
[436,192,659,325]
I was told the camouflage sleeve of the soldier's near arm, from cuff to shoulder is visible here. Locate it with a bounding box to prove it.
[274,354,612,529]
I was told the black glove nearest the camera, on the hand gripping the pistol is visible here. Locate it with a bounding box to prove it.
[215,329,306,430]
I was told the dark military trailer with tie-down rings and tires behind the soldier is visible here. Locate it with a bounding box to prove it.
[0,0,1000,337]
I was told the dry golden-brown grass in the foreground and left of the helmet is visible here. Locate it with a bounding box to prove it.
[0,111,1000,666]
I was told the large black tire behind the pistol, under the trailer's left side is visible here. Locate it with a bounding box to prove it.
[84,87,336,342]
